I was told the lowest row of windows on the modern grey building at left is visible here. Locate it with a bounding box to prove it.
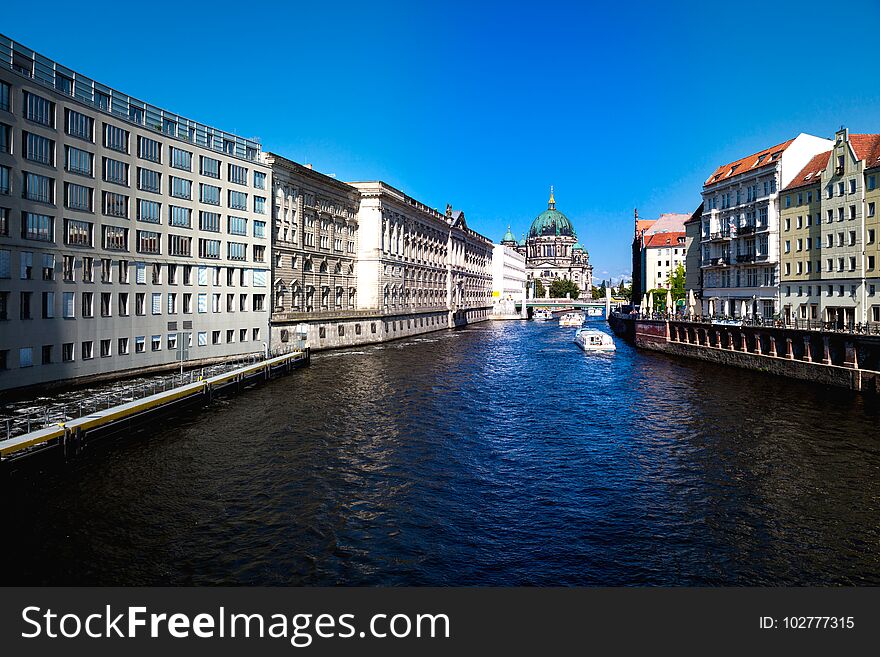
[0,328,261,370]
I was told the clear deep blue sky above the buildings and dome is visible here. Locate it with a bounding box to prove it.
[6,0,880,279]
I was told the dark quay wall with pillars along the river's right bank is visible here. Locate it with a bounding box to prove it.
[609,315,880,393]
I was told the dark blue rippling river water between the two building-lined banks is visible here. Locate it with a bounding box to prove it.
[0,322,880,585]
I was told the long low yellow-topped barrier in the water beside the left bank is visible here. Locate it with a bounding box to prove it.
[0,349,310,461]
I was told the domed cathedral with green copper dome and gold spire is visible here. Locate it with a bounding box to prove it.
[501,187,593,297]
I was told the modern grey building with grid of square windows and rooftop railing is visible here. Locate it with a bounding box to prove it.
[0,37,270,389]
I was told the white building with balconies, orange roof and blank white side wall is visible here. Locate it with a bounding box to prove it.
[700,134,832,318]
